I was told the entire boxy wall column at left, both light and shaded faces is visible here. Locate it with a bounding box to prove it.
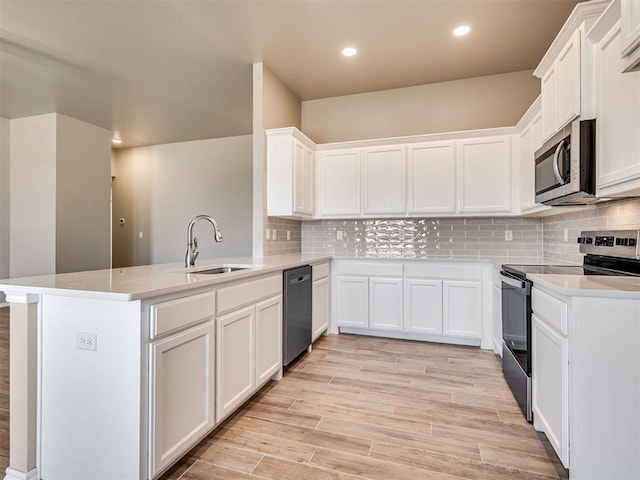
[9,113,110,277]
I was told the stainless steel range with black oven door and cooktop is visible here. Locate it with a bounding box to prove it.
[500,229,640,422]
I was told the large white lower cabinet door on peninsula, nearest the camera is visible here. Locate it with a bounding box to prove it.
[149,320,215,475]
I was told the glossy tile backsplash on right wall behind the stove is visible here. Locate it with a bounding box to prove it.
[543,200,640,263]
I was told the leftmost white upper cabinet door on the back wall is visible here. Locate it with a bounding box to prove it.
[318,149,362,217]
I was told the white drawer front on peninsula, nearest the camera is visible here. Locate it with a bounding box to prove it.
[151,292,216,338]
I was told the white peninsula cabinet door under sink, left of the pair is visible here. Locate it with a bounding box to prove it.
[216,305,255,422]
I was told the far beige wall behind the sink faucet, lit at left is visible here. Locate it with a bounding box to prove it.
[113,135,252,267]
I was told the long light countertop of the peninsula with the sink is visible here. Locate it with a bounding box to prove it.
[0,254,331,301]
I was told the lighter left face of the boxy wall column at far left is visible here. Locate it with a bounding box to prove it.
[9,113,57,277]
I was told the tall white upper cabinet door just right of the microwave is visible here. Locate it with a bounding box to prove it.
[596,23,640,195]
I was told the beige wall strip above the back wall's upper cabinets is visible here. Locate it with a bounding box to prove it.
[302,71,540,143]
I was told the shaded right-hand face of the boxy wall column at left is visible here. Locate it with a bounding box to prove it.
[56,115,111,273]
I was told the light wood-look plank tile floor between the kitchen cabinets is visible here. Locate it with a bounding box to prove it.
[162,335,568,480]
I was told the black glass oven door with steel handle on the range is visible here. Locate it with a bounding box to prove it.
[500,271,531,375]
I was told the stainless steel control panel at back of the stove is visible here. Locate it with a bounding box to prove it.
[578,229,640,260]
